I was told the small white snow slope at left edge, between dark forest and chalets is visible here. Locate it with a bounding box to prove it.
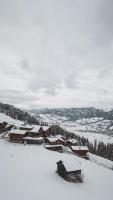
[0,113,23,126]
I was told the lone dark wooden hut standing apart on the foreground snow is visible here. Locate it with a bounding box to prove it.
[56,160,83,183]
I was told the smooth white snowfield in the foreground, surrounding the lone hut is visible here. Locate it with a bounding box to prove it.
[0,139,113,200]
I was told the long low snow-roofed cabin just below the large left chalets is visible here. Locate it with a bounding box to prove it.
[23,137,43,144]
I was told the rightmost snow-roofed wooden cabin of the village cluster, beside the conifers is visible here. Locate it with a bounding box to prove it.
[70,146,89,159]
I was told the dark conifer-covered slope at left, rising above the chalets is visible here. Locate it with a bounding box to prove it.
[0,103,40,124]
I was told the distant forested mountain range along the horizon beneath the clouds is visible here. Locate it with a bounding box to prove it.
[30,107,113,121]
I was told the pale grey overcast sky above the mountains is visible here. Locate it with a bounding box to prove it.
[0,0,113,109]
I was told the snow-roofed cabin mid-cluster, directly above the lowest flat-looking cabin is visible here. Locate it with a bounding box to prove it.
[44,137,65,145]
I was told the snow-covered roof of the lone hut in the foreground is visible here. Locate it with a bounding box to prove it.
[60,159,81,172]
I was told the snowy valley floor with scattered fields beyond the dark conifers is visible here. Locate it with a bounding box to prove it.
[36,114,113,144]
